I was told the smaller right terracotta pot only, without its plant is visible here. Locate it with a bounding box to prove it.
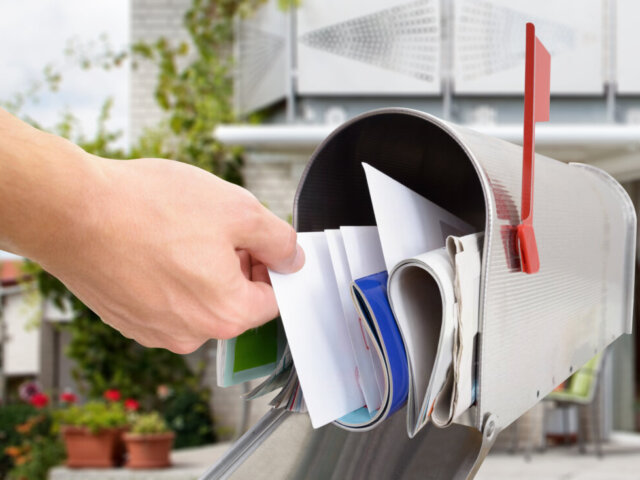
[124,432,176,468]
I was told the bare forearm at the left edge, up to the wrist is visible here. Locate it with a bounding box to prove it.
[0,109,99,263]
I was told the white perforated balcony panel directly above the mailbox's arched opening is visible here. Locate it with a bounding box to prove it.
[298,0,440,95]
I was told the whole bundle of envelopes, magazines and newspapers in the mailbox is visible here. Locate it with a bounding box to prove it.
[218,163,482,436]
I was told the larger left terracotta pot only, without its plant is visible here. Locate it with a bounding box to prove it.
[61,426,124,468]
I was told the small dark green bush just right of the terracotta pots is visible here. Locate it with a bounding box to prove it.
[161,386,215,448]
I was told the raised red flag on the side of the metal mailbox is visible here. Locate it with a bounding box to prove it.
[518,23,551,273]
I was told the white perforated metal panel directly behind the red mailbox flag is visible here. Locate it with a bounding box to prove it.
[454,0,604,95]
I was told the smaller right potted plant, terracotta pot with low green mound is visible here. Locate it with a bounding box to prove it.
[124,412,175,468]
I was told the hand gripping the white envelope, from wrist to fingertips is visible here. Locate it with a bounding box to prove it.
[39,157,304,353]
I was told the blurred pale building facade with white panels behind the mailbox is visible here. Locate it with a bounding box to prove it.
[130,0,640,436]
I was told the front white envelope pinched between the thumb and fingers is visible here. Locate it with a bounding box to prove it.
[269,232,364,428]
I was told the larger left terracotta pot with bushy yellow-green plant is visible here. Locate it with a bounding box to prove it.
[57,401,129,468]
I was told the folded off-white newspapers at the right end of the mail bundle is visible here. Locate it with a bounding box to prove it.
[388,234,482,437]
